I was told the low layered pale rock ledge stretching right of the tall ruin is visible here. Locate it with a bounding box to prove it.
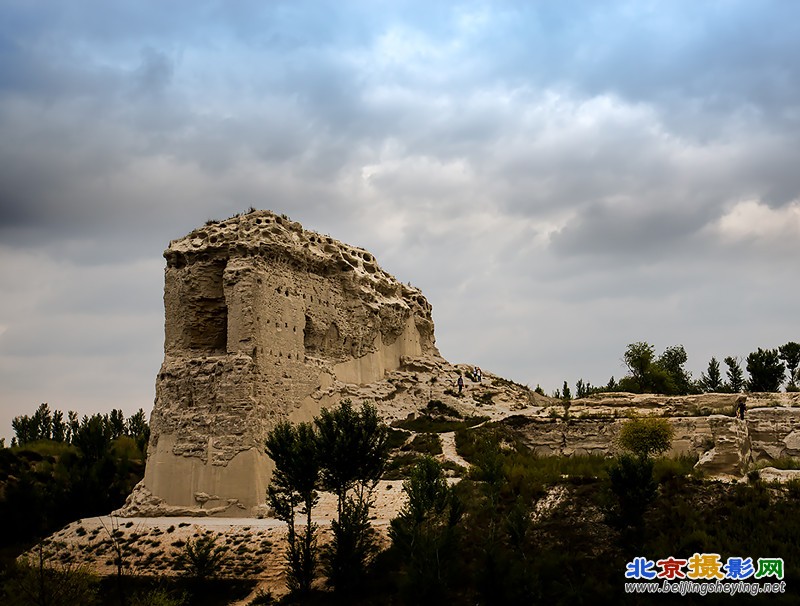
[490,393,800,479]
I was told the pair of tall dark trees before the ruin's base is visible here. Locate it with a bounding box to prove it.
[265,400,389,594]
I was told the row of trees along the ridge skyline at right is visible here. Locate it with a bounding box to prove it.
[553,341,800,400]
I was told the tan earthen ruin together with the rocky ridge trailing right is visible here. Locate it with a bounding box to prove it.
[117,211,800,517]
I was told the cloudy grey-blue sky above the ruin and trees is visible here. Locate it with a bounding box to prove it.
[0,0,800,443]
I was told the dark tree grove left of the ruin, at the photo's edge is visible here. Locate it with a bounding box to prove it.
[0,404,150,551]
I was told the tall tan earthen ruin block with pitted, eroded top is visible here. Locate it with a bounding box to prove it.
[138,211,439,516]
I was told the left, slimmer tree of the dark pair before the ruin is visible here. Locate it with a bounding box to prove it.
[265,421,320,593]
